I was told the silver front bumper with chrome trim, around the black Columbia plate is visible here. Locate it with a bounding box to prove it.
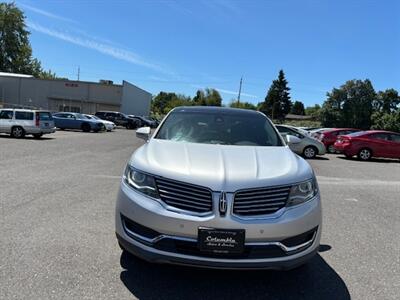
[116,182,321,269]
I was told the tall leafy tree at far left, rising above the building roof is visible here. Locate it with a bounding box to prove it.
[0,3,56,78]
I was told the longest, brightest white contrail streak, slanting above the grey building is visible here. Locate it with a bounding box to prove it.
[27,22,172,74]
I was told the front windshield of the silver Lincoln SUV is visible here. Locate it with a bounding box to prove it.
[155,112,282,146]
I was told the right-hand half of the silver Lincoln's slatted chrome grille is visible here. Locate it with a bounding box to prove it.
[233,186,291,216]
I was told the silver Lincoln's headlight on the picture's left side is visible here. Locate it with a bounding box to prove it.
[124,165,160,198]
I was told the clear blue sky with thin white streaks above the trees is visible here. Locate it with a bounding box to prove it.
[12,0,400,105]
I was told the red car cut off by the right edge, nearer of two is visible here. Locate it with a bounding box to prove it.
[334,130,400,160]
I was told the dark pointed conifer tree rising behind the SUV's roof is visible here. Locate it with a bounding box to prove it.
[260,70,292,120]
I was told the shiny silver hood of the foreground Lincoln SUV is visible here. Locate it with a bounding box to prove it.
[129,139,313,192]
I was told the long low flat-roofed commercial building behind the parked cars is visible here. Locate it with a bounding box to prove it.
[0,73,152,116]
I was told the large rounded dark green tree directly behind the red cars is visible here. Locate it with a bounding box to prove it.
[321,79,376,129]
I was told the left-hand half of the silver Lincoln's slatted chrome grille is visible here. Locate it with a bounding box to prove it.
[155,178,212,214]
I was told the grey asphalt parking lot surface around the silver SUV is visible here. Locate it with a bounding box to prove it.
[0,129,400,299]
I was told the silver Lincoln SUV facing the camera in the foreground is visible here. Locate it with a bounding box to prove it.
[115,107,322,269]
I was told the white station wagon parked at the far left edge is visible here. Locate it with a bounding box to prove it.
[0,108,56,138]
